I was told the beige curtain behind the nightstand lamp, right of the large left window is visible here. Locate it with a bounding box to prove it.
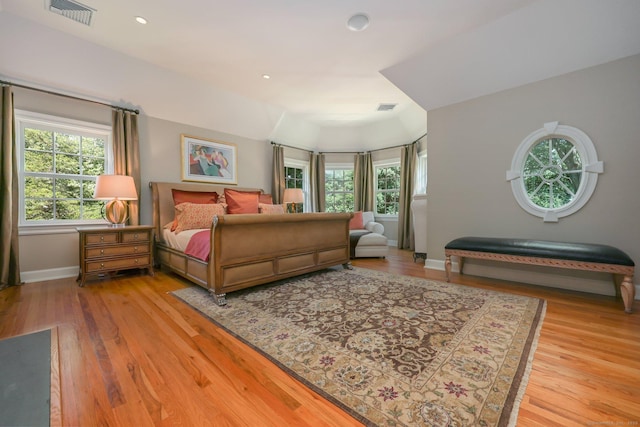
[111,109,142,225]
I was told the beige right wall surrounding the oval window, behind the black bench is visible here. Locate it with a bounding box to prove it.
[427,55,640,293]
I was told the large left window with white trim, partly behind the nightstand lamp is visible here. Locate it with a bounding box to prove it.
[15,110,113,226]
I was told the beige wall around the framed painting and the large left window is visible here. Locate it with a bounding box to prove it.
[14,88,271,281]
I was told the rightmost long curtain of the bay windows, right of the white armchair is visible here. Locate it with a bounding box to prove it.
[398,142,418,250]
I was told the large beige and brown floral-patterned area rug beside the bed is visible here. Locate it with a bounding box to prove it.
[174,268,546,426]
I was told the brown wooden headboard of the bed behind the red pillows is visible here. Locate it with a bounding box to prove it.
[149,182,263,240]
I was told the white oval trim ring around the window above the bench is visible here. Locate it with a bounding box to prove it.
[507,122,604,222]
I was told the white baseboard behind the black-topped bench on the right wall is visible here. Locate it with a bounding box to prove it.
[424,259,640,300]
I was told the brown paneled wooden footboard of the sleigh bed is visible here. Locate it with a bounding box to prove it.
[208,213,351,304]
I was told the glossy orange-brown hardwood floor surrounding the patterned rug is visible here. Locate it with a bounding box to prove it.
[0,249,640,426]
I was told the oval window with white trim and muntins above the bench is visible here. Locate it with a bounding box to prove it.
[507,122,603,222]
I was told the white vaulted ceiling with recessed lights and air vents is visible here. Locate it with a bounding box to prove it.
[0,0,640,151]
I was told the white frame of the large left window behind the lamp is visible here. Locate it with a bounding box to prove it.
[15,110,114,230]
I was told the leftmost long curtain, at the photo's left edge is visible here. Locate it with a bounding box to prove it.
[0,86,20,289]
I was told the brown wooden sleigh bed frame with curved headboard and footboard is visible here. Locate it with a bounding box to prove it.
[149,182,352,305]
